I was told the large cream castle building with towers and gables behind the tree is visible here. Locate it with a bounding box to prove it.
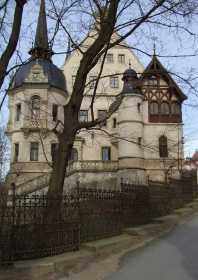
[7,0,186,192]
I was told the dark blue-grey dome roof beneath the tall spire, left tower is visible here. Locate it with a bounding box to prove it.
[12,59,66,91]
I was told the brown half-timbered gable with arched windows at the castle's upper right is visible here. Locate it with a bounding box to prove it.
[142,55,186,123]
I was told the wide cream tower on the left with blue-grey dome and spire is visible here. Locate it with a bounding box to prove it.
[7,0,67,191]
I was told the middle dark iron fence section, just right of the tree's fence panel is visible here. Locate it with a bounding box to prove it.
[79,188,123,242]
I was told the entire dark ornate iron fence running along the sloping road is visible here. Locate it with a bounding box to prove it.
[0,175,197,263]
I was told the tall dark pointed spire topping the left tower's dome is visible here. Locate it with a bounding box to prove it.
[29,0,53,60]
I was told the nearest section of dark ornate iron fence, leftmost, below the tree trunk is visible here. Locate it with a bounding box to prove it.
[0,191,79,262]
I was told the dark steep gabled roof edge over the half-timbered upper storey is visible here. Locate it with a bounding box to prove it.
[141,54,187,101]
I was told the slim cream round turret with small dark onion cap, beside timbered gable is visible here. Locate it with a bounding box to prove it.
[118,65,145,184]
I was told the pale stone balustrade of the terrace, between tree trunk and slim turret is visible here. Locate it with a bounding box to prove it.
[67,160,118,175]
